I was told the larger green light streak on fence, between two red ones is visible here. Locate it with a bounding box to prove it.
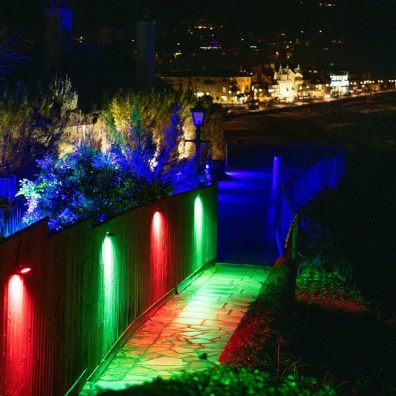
[99,234,118,355]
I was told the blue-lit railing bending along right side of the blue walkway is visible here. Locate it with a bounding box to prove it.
[276,146,345,258]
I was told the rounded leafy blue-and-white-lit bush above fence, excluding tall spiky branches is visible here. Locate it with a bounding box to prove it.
[18,146,175,230]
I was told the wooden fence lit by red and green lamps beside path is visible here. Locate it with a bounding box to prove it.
[0,186,217,396]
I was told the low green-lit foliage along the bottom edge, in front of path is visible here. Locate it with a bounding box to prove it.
[97,365,337,396]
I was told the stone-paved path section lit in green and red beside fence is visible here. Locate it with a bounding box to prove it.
[81,264,269,395]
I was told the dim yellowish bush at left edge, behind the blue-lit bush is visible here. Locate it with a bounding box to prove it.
[0,78,78,174]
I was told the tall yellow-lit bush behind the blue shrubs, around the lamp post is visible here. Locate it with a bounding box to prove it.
[99,91,224,160]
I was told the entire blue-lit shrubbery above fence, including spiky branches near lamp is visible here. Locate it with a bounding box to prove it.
[18,108,198,230]
